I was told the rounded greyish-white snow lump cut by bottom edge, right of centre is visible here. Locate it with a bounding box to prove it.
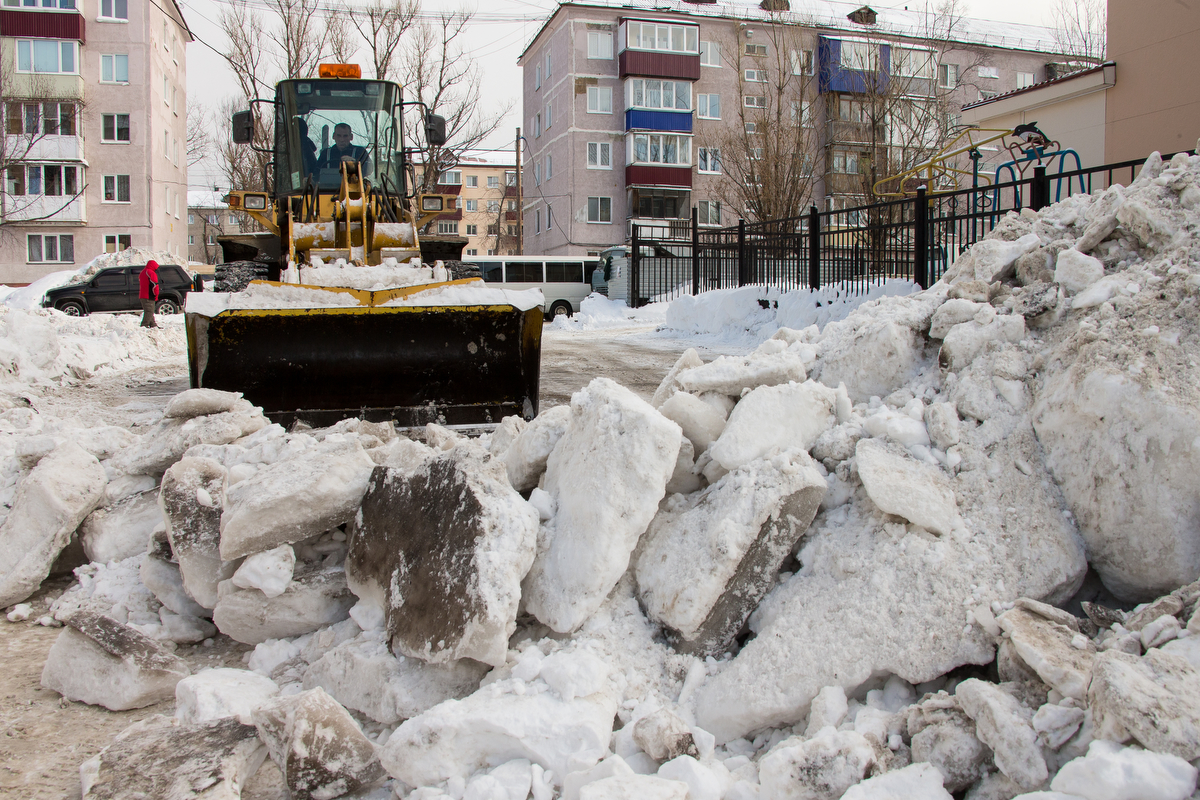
[758,728,878,800]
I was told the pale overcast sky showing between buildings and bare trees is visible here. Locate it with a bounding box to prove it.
[180,0,1051,188]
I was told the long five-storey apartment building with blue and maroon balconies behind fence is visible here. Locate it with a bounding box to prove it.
[520,0,1055,254]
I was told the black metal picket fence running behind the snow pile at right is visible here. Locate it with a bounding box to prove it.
[629,156,1169,306]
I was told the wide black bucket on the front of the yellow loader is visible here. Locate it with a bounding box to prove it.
[186,284,542,427]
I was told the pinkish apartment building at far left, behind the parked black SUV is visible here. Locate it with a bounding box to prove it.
[0,0,192,283]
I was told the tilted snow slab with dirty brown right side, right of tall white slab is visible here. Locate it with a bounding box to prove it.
[636,450,828,656]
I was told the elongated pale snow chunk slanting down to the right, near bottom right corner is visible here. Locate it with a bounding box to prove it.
[954,678,1049,789]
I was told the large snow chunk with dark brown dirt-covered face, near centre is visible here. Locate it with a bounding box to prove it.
[346,448,538,666]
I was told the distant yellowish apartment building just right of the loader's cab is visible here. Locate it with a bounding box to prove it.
[416,156,521,257]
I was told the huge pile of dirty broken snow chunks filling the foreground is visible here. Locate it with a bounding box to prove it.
[7,143,1200,800]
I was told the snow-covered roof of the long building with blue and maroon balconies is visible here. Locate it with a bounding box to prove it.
[521,0,1060,58]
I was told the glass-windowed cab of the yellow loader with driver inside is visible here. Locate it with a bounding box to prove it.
[275,78,406,197]
